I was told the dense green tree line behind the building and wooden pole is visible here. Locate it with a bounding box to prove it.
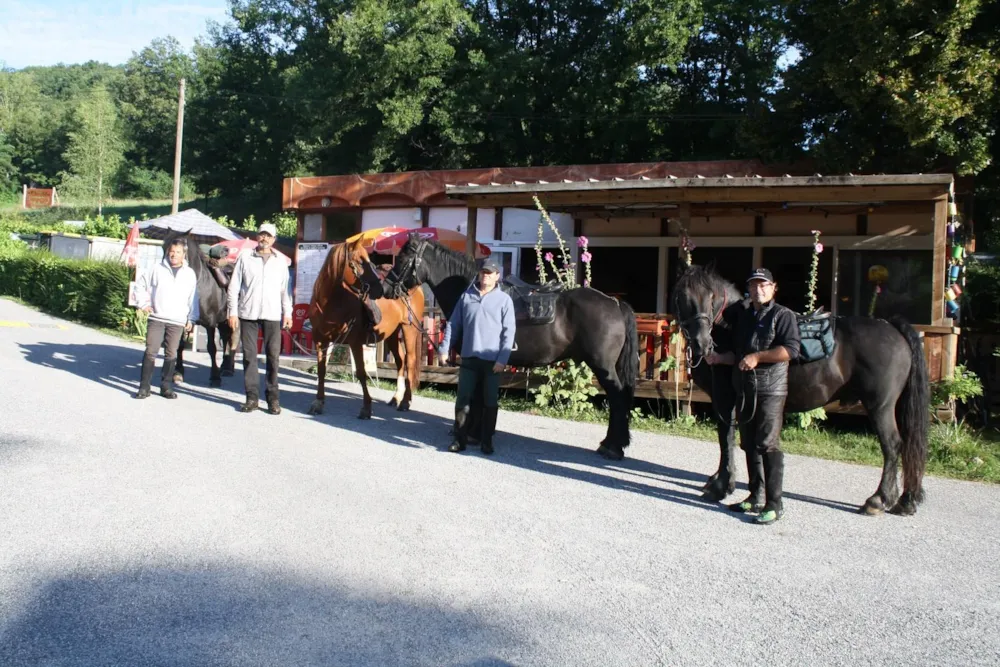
[0,0,1000,237]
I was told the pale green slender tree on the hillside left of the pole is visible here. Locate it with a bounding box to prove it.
[63,87,124,215]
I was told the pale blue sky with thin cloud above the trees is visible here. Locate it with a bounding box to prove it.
[0,0,228,69]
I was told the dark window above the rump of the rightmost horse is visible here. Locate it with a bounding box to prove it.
[837,250,934,324]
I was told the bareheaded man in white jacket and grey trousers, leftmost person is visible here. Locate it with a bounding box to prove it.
[134,239,198,398]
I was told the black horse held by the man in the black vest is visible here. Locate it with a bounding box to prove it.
[672,266,930,514]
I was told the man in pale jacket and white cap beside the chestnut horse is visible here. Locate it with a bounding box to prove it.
[228,223,292,415]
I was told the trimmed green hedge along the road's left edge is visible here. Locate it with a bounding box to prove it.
[0,250,131,329]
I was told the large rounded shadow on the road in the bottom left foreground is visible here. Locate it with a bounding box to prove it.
[0,568,524,667]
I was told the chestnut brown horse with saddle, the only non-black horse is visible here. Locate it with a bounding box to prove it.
[309,241,424,419]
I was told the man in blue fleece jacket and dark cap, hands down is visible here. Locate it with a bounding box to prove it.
[438,259,515,454]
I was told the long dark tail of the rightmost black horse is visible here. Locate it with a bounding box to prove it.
[890,317,931,503]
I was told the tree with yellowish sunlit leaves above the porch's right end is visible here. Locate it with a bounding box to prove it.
[778,0,1000,174]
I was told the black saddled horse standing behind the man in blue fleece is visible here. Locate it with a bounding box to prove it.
[387,234,639,460]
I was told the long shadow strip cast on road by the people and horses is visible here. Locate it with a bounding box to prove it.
[13,343,855,518]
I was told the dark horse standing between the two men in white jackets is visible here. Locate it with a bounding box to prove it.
[163,233,238,387]
